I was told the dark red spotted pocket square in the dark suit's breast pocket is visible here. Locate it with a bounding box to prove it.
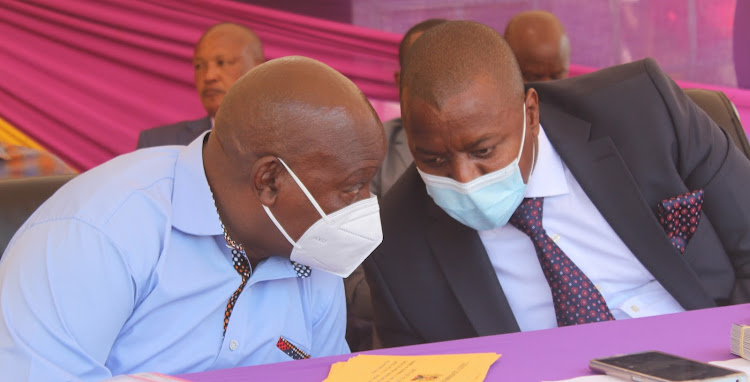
[657,189,703,253]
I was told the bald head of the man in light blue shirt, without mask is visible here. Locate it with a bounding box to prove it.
[203,57,386,259]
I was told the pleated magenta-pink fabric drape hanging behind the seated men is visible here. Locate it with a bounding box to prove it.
[0,0,750,170]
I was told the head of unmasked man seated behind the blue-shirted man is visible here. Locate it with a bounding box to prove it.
[193,23,265,117]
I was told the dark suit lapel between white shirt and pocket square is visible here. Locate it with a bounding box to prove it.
[540,104,715,309]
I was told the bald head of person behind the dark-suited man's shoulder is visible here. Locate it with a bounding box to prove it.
[503,11,570,82]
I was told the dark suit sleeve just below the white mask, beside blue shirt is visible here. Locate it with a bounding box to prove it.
[365,250,425,348]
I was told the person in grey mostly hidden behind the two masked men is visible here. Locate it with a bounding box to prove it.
[344,19,447,351]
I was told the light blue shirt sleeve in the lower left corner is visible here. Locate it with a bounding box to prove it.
[0,220,135,381]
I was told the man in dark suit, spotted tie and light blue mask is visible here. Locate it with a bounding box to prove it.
[365,21,750,347]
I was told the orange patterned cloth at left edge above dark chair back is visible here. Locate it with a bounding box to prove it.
[0,142,75,179]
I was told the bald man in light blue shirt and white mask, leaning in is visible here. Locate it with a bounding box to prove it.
[0,57,385,381]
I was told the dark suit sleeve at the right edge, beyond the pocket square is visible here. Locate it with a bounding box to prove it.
[645,60,750,304]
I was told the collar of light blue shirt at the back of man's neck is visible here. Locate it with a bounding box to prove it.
[172,131,224,236]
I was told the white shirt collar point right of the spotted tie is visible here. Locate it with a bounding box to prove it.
[524,125,570,198]
